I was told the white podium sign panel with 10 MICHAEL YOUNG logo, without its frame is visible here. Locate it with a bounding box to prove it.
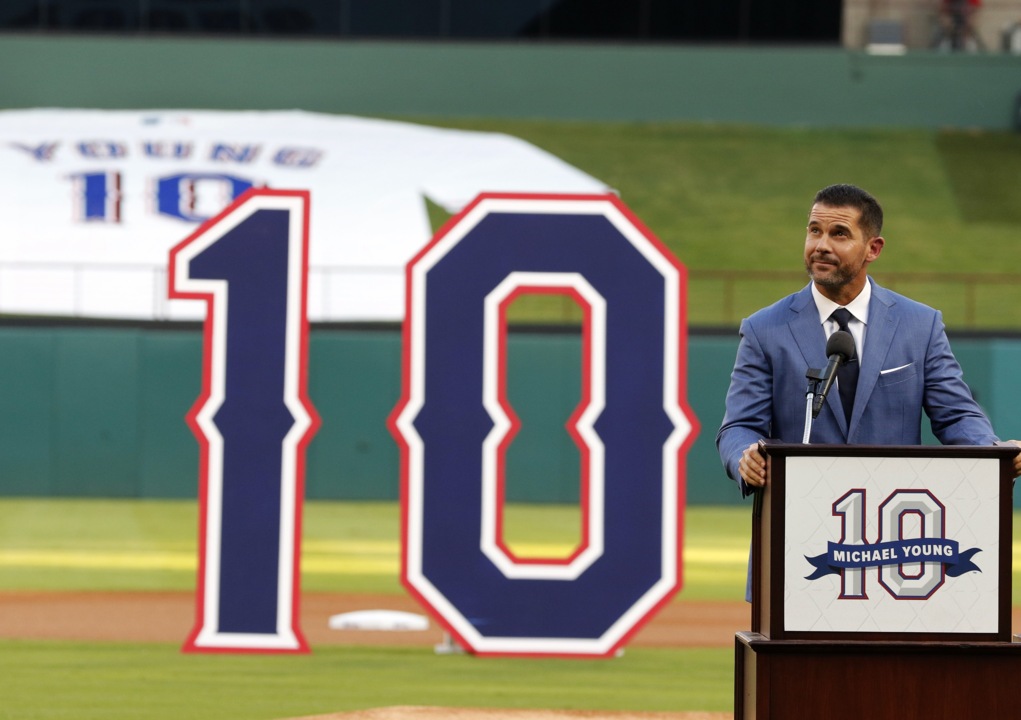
[783,457,996,633]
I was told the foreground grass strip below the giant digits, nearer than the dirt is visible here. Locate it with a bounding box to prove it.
[0,640,733,720]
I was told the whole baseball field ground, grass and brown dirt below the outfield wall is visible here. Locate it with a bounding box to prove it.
[0,499,1021,720]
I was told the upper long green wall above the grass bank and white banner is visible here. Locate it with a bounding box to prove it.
[0,35,1021,129]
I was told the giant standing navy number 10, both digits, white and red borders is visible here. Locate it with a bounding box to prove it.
[171,190,694,656]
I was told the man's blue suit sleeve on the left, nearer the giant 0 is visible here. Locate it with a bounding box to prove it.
[716,320,773,494]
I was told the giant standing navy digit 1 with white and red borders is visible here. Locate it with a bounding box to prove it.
[169,190,319,652]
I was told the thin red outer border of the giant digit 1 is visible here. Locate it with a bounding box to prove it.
[167,188,322,654]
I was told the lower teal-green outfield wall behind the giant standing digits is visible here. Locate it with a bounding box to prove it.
[0,325,1021,503]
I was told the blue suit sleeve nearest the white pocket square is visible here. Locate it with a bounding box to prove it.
[922,311,999,445]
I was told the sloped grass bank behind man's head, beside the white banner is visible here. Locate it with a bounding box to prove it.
[412,118,1021,328]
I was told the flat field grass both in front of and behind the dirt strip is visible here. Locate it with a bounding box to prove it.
[0,498,747,720]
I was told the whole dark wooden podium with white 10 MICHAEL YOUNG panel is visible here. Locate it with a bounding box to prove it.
[734,441,1021,720]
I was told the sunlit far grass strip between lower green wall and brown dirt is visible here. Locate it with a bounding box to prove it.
[0,498,749,599]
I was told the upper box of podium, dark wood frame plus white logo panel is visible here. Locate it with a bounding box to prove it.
[752,445,1012,641]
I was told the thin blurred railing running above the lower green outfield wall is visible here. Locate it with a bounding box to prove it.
[0,262,1021,331]
